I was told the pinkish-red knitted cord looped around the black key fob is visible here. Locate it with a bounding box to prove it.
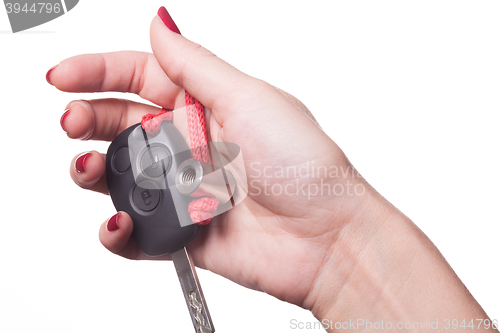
[141,91,219,225]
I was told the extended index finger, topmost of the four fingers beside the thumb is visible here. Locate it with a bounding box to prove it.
[47,51,181,109]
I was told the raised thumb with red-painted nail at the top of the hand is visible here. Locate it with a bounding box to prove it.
[150,7,254,121]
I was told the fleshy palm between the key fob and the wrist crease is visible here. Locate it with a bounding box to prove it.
[174,78,346,304]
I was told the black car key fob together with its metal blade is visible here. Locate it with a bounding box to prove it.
[106,121,215,333]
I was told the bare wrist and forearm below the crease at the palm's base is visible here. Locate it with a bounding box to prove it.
[303,186,494,329]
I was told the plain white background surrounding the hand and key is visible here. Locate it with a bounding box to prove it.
[0,0,500,333]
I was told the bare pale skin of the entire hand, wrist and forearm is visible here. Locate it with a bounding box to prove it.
[50,17,494,331]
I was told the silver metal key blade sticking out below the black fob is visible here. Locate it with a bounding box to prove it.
[170,247,215,333]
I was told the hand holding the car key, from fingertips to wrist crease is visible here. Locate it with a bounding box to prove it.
[50,14,360,306]
